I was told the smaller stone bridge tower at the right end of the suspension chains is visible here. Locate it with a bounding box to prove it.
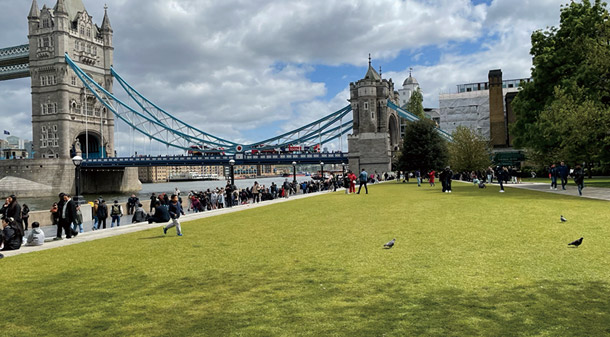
[347,57,400,174]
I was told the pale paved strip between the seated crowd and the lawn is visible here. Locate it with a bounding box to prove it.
[2,189,339,258]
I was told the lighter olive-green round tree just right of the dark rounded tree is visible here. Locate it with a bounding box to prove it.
[448,126,491,172]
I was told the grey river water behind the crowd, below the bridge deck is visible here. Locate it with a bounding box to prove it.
[17,176,304,211]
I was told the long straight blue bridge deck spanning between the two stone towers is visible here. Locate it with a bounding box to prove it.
[81,152,348,168]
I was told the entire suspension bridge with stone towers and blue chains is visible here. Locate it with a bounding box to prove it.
[0,0,450,193]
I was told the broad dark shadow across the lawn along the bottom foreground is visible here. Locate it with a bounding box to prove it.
[11,269,610,336]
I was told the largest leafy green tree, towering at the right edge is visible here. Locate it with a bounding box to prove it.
[511,0,610,163]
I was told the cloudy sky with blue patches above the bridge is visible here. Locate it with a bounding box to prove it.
[0,0,568,155]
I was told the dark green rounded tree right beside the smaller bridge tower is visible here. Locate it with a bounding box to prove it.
[398,119,447,174]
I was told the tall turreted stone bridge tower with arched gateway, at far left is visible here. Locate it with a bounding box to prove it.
[28,0,114,159]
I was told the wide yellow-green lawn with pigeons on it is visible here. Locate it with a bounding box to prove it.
[0,183,610,336]
